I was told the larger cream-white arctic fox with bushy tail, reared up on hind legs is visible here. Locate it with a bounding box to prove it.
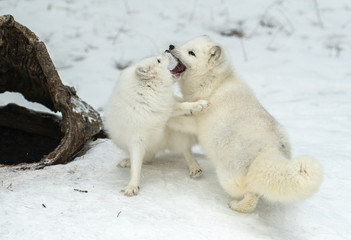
[169,36,323,212]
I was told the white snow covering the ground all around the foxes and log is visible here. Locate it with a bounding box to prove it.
[0,0,351,240]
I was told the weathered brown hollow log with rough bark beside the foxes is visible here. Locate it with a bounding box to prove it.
[0,15,102,168]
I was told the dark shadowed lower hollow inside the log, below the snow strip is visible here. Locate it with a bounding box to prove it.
[0,104,63,165]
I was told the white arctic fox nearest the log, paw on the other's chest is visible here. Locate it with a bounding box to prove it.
[105,53,208,196]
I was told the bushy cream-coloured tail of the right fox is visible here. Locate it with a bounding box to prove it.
[247,150,323,202]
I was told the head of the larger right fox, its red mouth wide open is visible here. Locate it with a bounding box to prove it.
[168,36,232,100]
